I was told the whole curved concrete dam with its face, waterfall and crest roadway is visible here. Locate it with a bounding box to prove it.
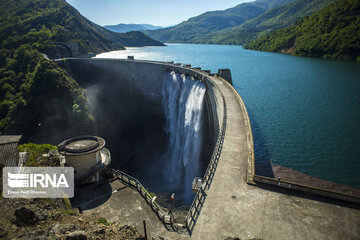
[58,59,360,239]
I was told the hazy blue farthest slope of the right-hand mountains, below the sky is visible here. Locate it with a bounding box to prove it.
[145,0,292,42]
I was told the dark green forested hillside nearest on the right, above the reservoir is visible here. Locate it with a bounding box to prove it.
[246,0,360,61]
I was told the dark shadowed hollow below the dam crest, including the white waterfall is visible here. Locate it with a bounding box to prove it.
[62,59,213,207]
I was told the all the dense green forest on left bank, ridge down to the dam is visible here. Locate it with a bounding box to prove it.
[0,0,162,140]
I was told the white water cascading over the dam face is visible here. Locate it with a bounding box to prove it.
[162,72,206,202]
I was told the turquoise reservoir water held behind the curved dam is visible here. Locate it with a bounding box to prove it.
[96,44,360,188]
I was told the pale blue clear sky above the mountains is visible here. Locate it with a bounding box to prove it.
[66,0,252,26]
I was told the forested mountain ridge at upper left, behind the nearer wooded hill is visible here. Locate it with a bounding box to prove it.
[0,0,162,54]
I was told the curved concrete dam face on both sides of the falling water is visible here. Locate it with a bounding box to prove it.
[57,58,224,155]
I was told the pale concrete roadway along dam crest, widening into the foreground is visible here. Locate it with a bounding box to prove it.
[80,76,360,240]
